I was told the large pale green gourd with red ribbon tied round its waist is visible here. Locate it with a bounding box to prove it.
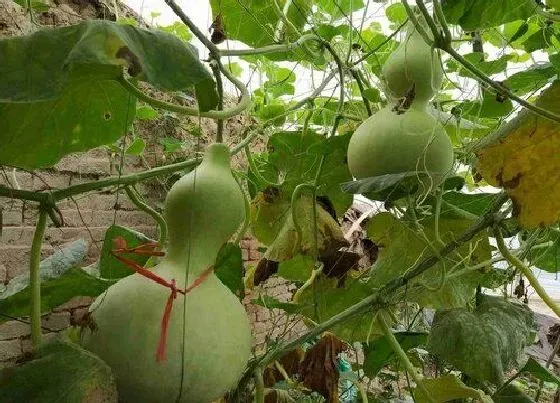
[83,144,251,403]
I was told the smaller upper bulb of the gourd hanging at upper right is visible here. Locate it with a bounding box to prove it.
[381,22,443,102]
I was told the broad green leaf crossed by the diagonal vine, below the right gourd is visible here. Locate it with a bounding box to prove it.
[367,213,490,308]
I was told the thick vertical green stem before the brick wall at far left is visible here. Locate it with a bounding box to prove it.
[29,205,48,348]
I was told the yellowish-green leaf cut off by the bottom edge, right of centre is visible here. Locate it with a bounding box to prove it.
[414,374,492,403]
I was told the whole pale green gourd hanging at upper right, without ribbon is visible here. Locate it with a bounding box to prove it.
[347,17,453,189]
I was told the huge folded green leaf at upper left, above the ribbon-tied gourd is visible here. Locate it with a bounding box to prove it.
[0,20,217,168]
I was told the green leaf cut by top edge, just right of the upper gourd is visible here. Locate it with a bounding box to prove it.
[441,0,537,31]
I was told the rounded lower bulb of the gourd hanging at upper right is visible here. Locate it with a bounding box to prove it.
[348,103,453,185]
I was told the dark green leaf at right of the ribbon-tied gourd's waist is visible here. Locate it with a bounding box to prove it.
[214,242,245,298]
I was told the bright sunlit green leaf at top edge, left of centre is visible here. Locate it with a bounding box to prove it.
[210,0,312,47]
